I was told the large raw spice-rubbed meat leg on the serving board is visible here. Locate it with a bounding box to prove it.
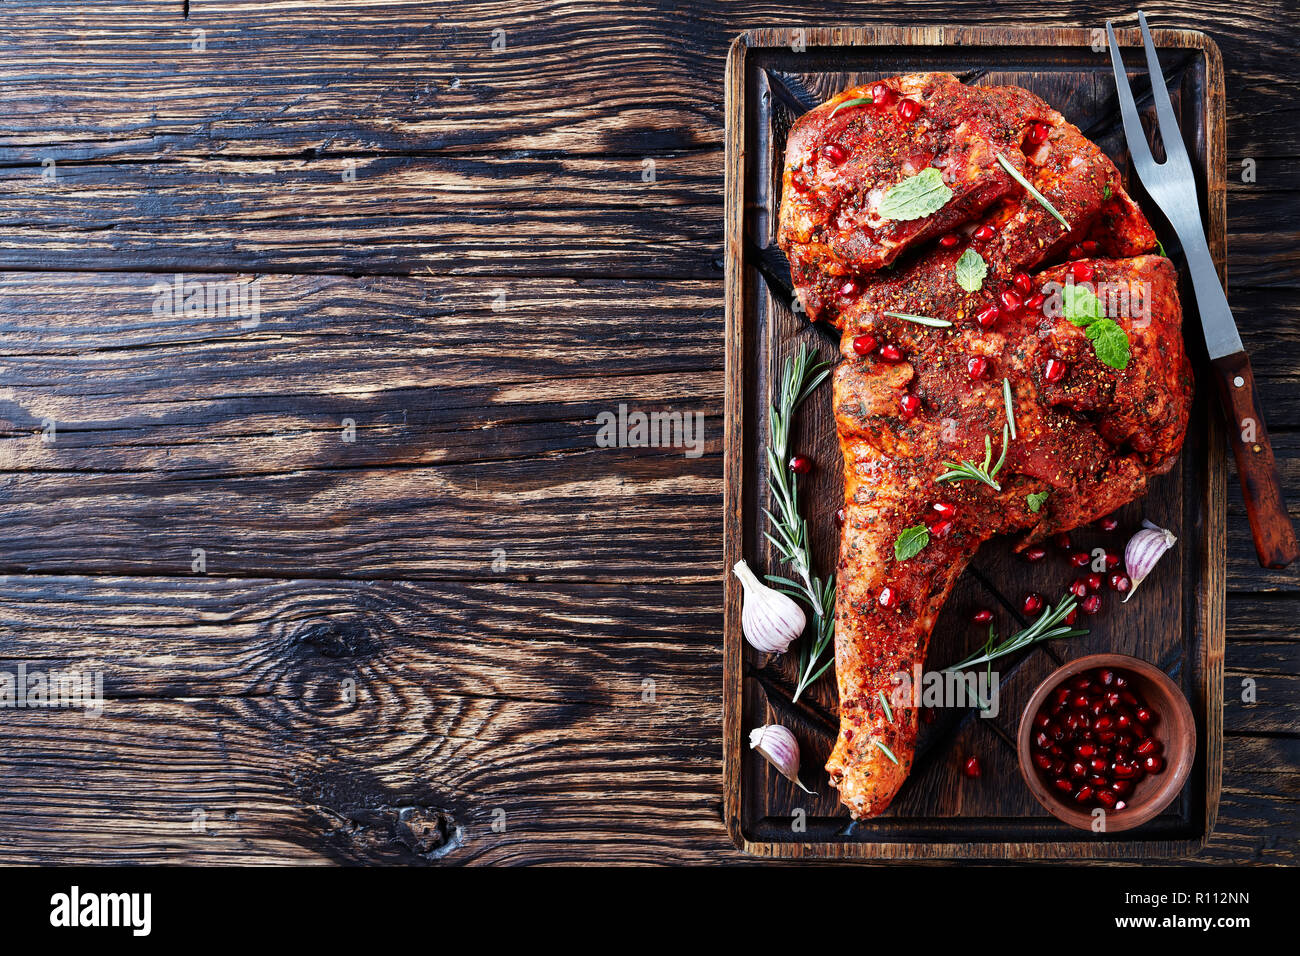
[779,74,1192,817]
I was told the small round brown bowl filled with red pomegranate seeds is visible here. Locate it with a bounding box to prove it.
[1018,654,1196,832]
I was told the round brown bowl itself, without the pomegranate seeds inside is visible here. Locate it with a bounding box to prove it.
[1017,654,1196,832]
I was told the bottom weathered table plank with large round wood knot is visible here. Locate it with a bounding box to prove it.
[0,578,722,862]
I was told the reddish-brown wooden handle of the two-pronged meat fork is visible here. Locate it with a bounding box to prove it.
[1212,351,1297,568]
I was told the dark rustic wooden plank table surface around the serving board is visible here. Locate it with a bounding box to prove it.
[0,0,1300,864]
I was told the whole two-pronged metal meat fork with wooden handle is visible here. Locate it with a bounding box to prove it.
[1106,12,1297,568]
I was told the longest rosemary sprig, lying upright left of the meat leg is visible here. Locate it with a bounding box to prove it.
[763,345,835,700]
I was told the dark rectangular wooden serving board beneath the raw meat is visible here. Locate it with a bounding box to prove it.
[724,27,1226,860]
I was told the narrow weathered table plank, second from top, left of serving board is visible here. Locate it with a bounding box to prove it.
[0,152,722,278]
